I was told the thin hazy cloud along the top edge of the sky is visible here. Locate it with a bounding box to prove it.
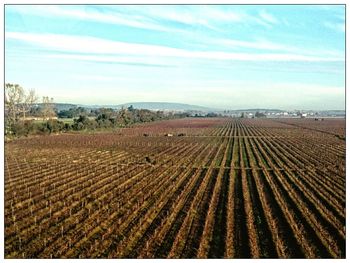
[5,5,277,33]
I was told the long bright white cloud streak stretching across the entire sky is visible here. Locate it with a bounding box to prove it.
[5,32,343,62]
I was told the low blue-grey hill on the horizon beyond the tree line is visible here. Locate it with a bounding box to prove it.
[116,102,216,112]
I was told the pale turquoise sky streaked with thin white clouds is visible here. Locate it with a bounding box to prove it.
[5,5,345,110]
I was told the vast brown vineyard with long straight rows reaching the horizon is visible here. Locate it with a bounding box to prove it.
[4,118,346,258]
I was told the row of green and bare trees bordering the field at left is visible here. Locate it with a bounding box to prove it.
[5,83,189,138]
